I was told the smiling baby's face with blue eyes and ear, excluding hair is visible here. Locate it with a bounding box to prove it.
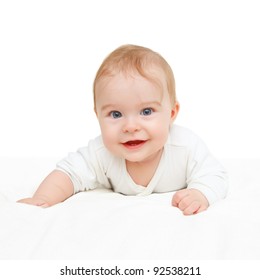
[96,71,178,162]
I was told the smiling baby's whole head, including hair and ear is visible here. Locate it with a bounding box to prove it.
[94,45,179,162]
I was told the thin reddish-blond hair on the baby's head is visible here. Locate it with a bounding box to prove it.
[93,45,176,107]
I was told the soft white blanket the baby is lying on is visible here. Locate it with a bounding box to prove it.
[0,158,260,260]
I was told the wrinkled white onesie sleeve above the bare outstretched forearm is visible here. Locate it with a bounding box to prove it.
[56,137,109,193]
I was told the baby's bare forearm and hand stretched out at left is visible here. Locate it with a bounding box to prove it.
[18,170,73,207]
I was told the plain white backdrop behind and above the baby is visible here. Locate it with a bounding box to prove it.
[0,0,260,158]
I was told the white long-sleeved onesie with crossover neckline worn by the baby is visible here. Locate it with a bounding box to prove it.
[57,125,228,204]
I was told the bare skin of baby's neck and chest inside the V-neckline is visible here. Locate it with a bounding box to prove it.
[126,149,163,187]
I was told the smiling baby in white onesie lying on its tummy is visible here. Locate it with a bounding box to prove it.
[19,45,227,215]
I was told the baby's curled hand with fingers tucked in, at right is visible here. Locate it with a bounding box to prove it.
[172,189,209,215]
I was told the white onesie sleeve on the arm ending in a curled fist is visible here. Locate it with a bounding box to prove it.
[187,135,228,204]
